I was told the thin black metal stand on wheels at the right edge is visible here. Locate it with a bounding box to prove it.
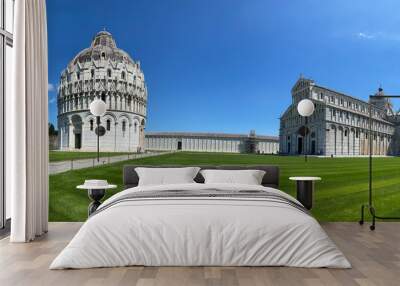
[359,94,400,230]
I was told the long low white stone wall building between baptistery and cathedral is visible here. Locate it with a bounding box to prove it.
[145,132,279,154]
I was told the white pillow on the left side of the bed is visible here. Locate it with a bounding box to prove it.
[135,167,200,186]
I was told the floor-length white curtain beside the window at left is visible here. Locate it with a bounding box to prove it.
[6,0,48,242]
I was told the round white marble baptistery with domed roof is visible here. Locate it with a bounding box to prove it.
[57,31,147,152]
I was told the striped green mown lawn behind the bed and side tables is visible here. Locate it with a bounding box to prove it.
[50,152,400,221]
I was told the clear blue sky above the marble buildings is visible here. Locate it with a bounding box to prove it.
[47,0,400,135]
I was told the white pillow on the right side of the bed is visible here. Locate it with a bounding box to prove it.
[200,169,265,185]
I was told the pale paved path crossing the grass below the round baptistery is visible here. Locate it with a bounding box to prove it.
[49,152,173,175]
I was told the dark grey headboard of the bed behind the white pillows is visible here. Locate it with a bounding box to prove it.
[123,165,279,189]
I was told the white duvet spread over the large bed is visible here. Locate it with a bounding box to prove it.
[50,183,351,269]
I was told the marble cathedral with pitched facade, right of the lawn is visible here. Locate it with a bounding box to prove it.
[279,77,400,156]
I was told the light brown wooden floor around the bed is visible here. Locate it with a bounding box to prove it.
[0,223,400,286]
